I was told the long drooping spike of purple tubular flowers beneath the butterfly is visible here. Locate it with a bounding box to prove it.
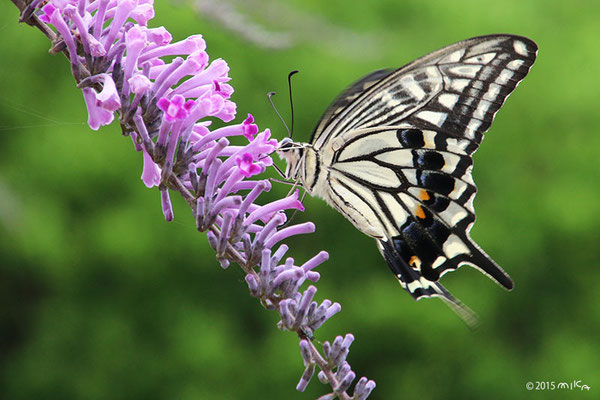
[13,0,375,399]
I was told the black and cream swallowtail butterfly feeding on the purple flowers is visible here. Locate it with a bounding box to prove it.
[278,35,537,322]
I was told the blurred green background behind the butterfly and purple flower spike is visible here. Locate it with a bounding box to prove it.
[0,0,600,400]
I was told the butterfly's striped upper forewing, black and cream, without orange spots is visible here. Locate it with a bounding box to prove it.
[311,35,537,149]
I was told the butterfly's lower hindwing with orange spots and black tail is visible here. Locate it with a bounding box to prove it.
[330,126,512,298]
